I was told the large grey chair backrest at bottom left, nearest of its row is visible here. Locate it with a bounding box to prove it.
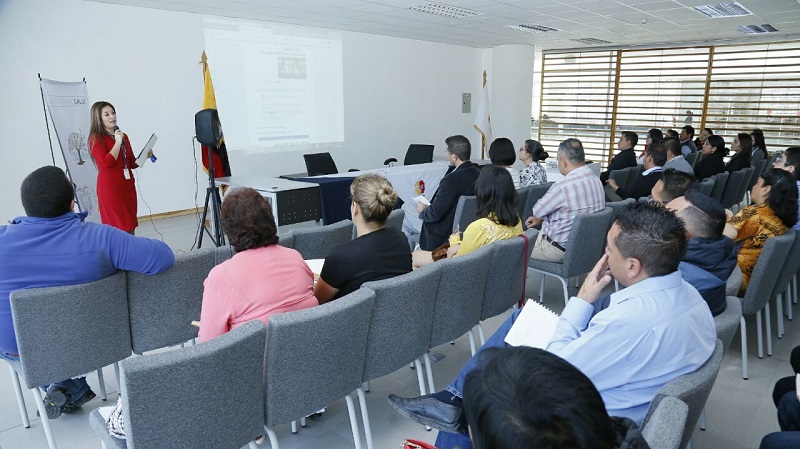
[121,320,267,449]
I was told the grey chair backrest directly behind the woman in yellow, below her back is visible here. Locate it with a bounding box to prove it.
[429,244,492,348]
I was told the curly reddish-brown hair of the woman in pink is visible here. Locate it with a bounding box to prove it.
[222,187,278,252]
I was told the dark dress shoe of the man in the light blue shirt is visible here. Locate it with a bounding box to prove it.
[389,394,466,433]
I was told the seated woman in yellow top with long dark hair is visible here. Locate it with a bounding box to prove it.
[413,165,522,268]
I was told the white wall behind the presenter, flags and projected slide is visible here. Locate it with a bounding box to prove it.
[0,0,482,220]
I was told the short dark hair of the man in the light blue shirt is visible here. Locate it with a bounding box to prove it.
[615,202,686,276]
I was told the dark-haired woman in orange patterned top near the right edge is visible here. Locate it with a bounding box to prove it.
[725,169,797,296]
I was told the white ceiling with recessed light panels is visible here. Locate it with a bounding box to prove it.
[87,0,800,50]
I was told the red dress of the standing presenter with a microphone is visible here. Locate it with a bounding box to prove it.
[89,134,139,232]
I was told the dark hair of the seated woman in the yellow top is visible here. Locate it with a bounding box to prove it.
[476,165,520,231]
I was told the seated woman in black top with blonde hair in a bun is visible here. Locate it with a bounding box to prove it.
[314,174,411,304]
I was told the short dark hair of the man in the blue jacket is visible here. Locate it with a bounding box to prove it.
[20,165,75,218]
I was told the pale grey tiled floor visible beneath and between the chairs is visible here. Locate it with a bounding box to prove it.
[0,215,800,449]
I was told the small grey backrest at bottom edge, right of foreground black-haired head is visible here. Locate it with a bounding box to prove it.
[642,396,689,449]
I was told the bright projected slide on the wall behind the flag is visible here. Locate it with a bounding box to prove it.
[204,19,344,154]
